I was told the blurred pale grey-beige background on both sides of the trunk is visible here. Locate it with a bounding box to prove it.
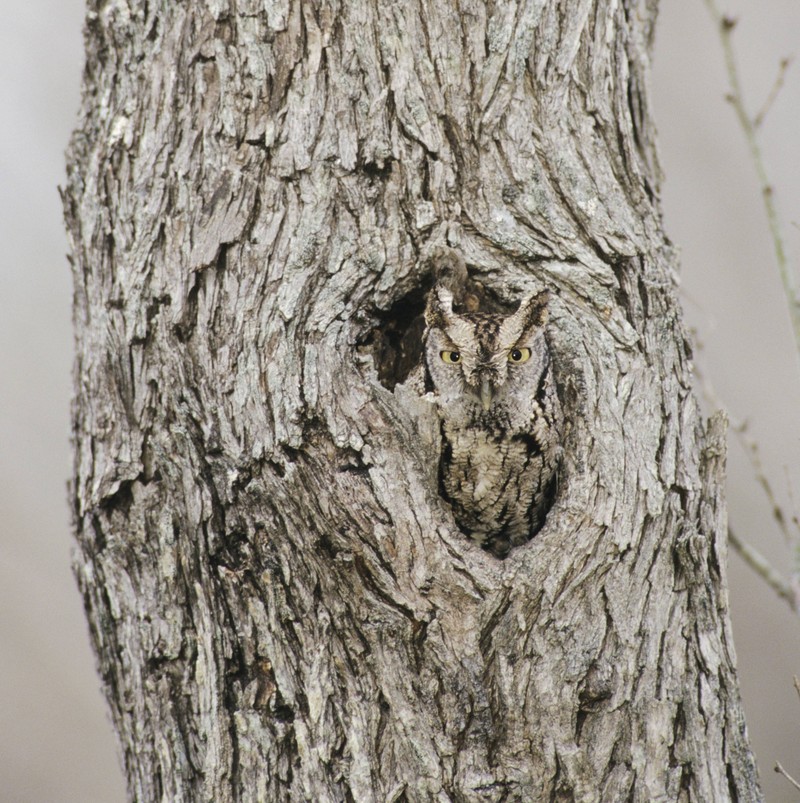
[0,0,800,803]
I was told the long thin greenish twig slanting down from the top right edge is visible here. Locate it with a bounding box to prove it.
[705,0,800,355]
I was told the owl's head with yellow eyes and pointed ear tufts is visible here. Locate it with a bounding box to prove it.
[425,286,549,415]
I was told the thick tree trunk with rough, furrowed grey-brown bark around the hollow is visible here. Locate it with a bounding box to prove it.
[64,0,760,803]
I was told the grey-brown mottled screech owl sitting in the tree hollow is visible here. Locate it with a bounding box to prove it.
[425,284,563,557]
